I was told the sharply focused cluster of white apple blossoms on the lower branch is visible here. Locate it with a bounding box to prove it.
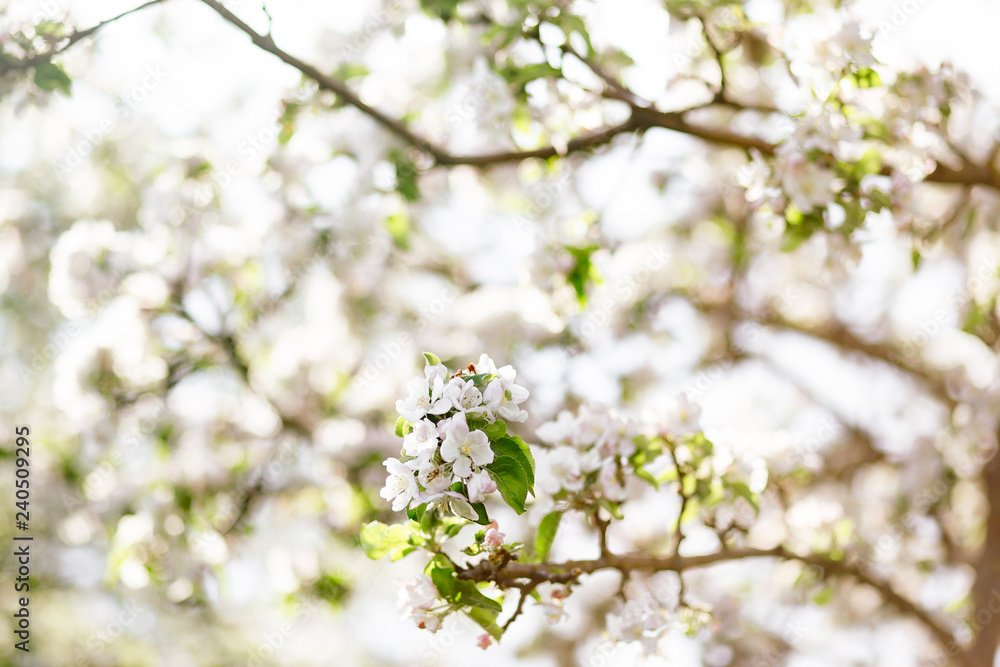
[380,354,528,520]
